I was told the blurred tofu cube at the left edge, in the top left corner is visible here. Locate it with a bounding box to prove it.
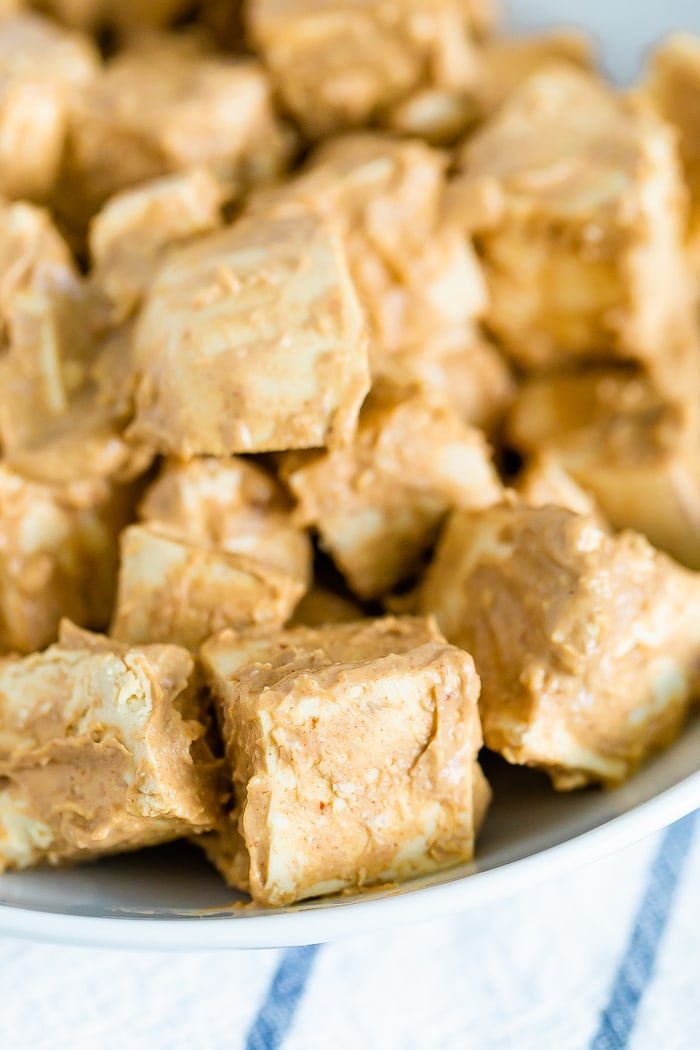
[0,13,100,202]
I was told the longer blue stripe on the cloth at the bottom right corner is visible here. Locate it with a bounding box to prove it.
[591,813,697,1050]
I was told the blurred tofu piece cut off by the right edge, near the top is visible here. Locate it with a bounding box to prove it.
[645,33,700,271]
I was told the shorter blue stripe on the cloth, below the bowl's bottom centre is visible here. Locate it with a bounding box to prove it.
[246,944,320,1050]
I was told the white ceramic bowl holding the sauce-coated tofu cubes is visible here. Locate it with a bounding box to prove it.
[0,0,700,949]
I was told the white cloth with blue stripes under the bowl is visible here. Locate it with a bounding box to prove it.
[0,816,700,1050]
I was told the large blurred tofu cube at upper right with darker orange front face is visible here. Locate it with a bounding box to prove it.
[455,65,695,370]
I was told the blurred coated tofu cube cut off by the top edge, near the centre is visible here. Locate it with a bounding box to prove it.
[246,0,488,138]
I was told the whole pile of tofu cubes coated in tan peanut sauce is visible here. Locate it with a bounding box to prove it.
[0,0,700,906]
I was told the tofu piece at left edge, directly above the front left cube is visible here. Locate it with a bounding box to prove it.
[0,464,132,652]
